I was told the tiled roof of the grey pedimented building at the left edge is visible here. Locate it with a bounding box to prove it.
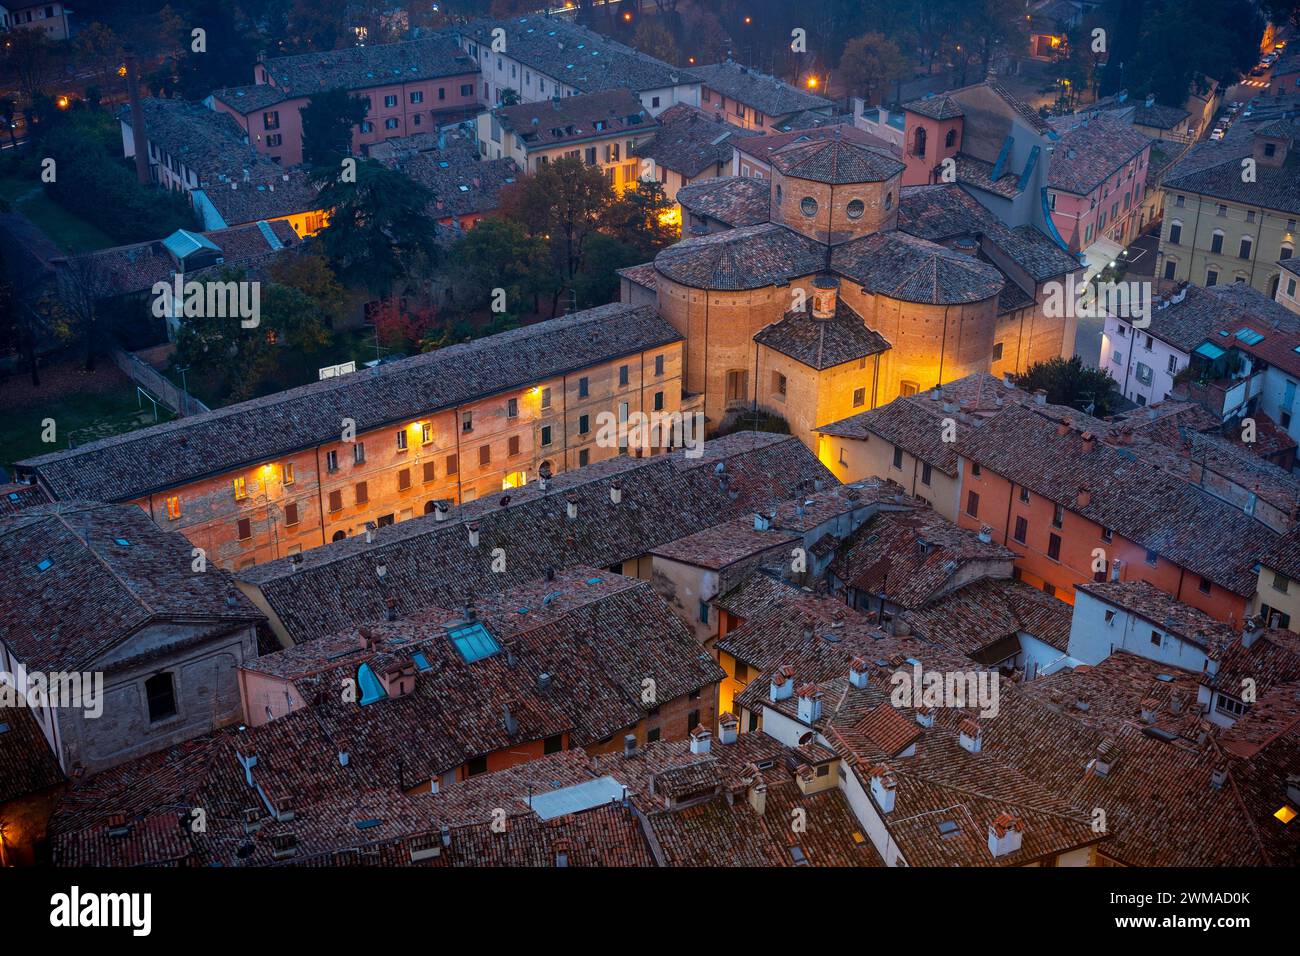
[0,502,263,671]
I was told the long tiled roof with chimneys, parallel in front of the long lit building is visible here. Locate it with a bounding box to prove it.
[241,433,833,641]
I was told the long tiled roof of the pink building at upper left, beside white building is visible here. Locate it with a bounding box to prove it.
[260,35,478,99]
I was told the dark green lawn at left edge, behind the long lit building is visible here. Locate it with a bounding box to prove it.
[0,385,174,468]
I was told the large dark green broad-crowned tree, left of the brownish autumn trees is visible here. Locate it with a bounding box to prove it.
[312,160,438,298]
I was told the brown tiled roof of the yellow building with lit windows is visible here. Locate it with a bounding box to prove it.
[493,88,659,150]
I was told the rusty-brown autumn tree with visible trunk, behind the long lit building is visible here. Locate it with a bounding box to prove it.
[501,157,614,316]
